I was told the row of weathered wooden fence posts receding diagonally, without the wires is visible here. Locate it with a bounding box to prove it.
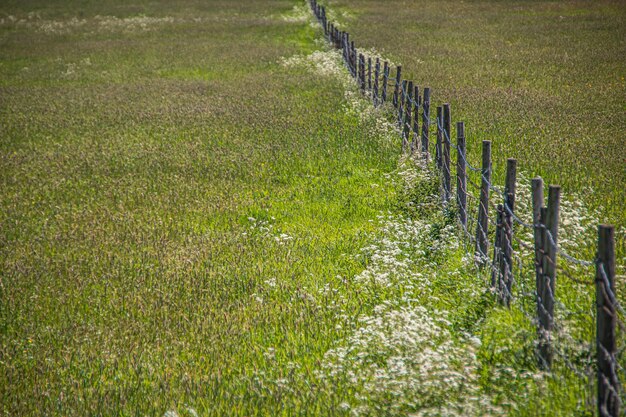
[310,0,620,417]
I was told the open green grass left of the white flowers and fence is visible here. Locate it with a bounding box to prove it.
[0,1,397,415]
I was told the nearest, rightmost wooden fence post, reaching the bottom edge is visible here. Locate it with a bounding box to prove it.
[596,225,620,417]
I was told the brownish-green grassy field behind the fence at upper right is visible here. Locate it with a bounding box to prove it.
[325,0,626,227]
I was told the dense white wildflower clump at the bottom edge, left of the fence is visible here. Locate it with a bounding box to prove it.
[318,303,501,416]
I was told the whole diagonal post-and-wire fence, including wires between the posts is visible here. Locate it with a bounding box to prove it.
[309,0,626,417]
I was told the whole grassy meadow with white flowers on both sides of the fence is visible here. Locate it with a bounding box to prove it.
[0,0,626,417]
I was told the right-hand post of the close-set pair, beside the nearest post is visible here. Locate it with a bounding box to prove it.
[538,185,561,369]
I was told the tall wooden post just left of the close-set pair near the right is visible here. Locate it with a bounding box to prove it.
[502,158,517,306]
